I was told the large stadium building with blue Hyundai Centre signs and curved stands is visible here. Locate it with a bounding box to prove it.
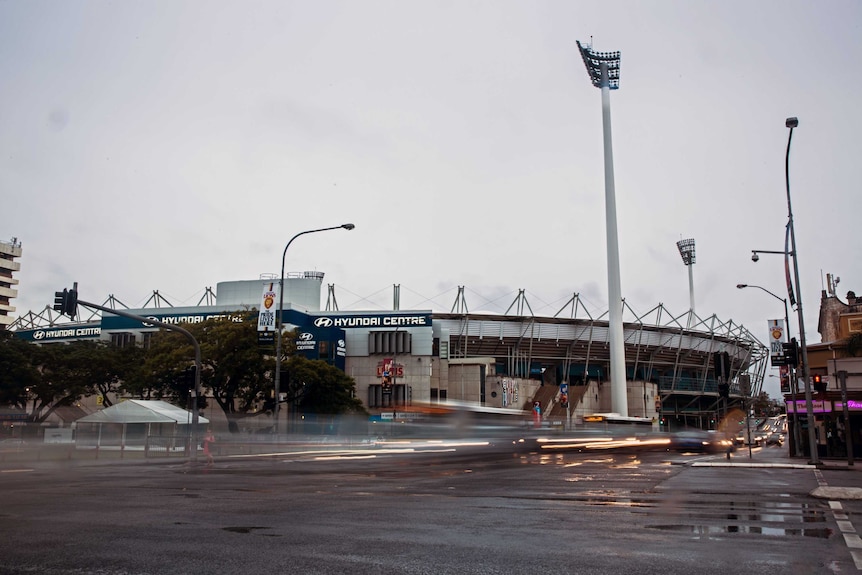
[10,271,769,429]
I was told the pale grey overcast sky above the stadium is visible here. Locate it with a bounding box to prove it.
[0,0,862,395]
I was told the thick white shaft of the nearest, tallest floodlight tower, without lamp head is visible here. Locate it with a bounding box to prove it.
[601,62,629,417]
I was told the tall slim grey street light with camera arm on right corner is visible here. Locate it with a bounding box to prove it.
[751,118,820,465]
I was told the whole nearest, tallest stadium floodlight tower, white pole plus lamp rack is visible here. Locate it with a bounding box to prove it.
[578,42,629,417]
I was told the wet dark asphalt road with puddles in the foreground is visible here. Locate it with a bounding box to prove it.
[0,440,862,575]
